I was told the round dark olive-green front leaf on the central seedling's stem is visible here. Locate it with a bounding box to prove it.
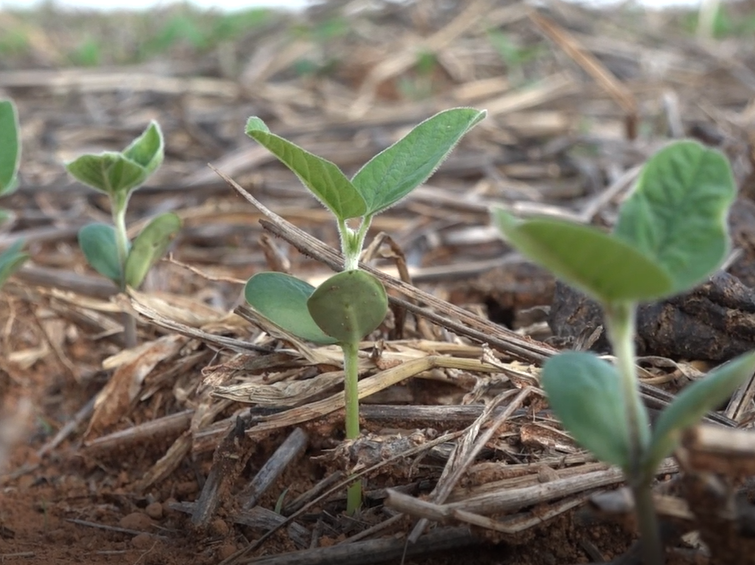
[307,270,388,343]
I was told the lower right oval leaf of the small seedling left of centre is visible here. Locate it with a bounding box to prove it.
[125,212,181,288]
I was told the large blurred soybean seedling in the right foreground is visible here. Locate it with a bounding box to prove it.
[492,141,755,565]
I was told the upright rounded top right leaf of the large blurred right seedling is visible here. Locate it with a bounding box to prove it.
[614,141,736,294]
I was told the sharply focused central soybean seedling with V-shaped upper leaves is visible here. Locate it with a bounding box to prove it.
[245,108,485,513]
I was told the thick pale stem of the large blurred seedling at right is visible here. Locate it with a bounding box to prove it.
[605,302,663,565]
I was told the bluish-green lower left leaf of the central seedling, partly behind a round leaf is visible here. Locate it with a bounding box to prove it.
[244,273,336,344]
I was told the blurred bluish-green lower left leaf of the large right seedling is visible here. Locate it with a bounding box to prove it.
[542,351,631,470]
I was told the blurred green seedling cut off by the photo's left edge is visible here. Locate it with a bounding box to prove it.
[0,100,29,287]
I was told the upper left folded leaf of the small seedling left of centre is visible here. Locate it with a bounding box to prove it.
[66,151,147,196]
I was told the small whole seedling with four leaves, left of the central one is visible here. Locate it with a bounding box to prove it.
[66,122,181,347]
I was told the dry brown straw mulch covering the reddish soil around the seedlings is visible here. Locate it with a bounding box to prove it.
[0,0,755,565]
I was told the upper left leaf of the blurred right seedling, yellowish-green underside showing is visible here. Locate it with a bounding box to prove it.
[492,208,672,304]
